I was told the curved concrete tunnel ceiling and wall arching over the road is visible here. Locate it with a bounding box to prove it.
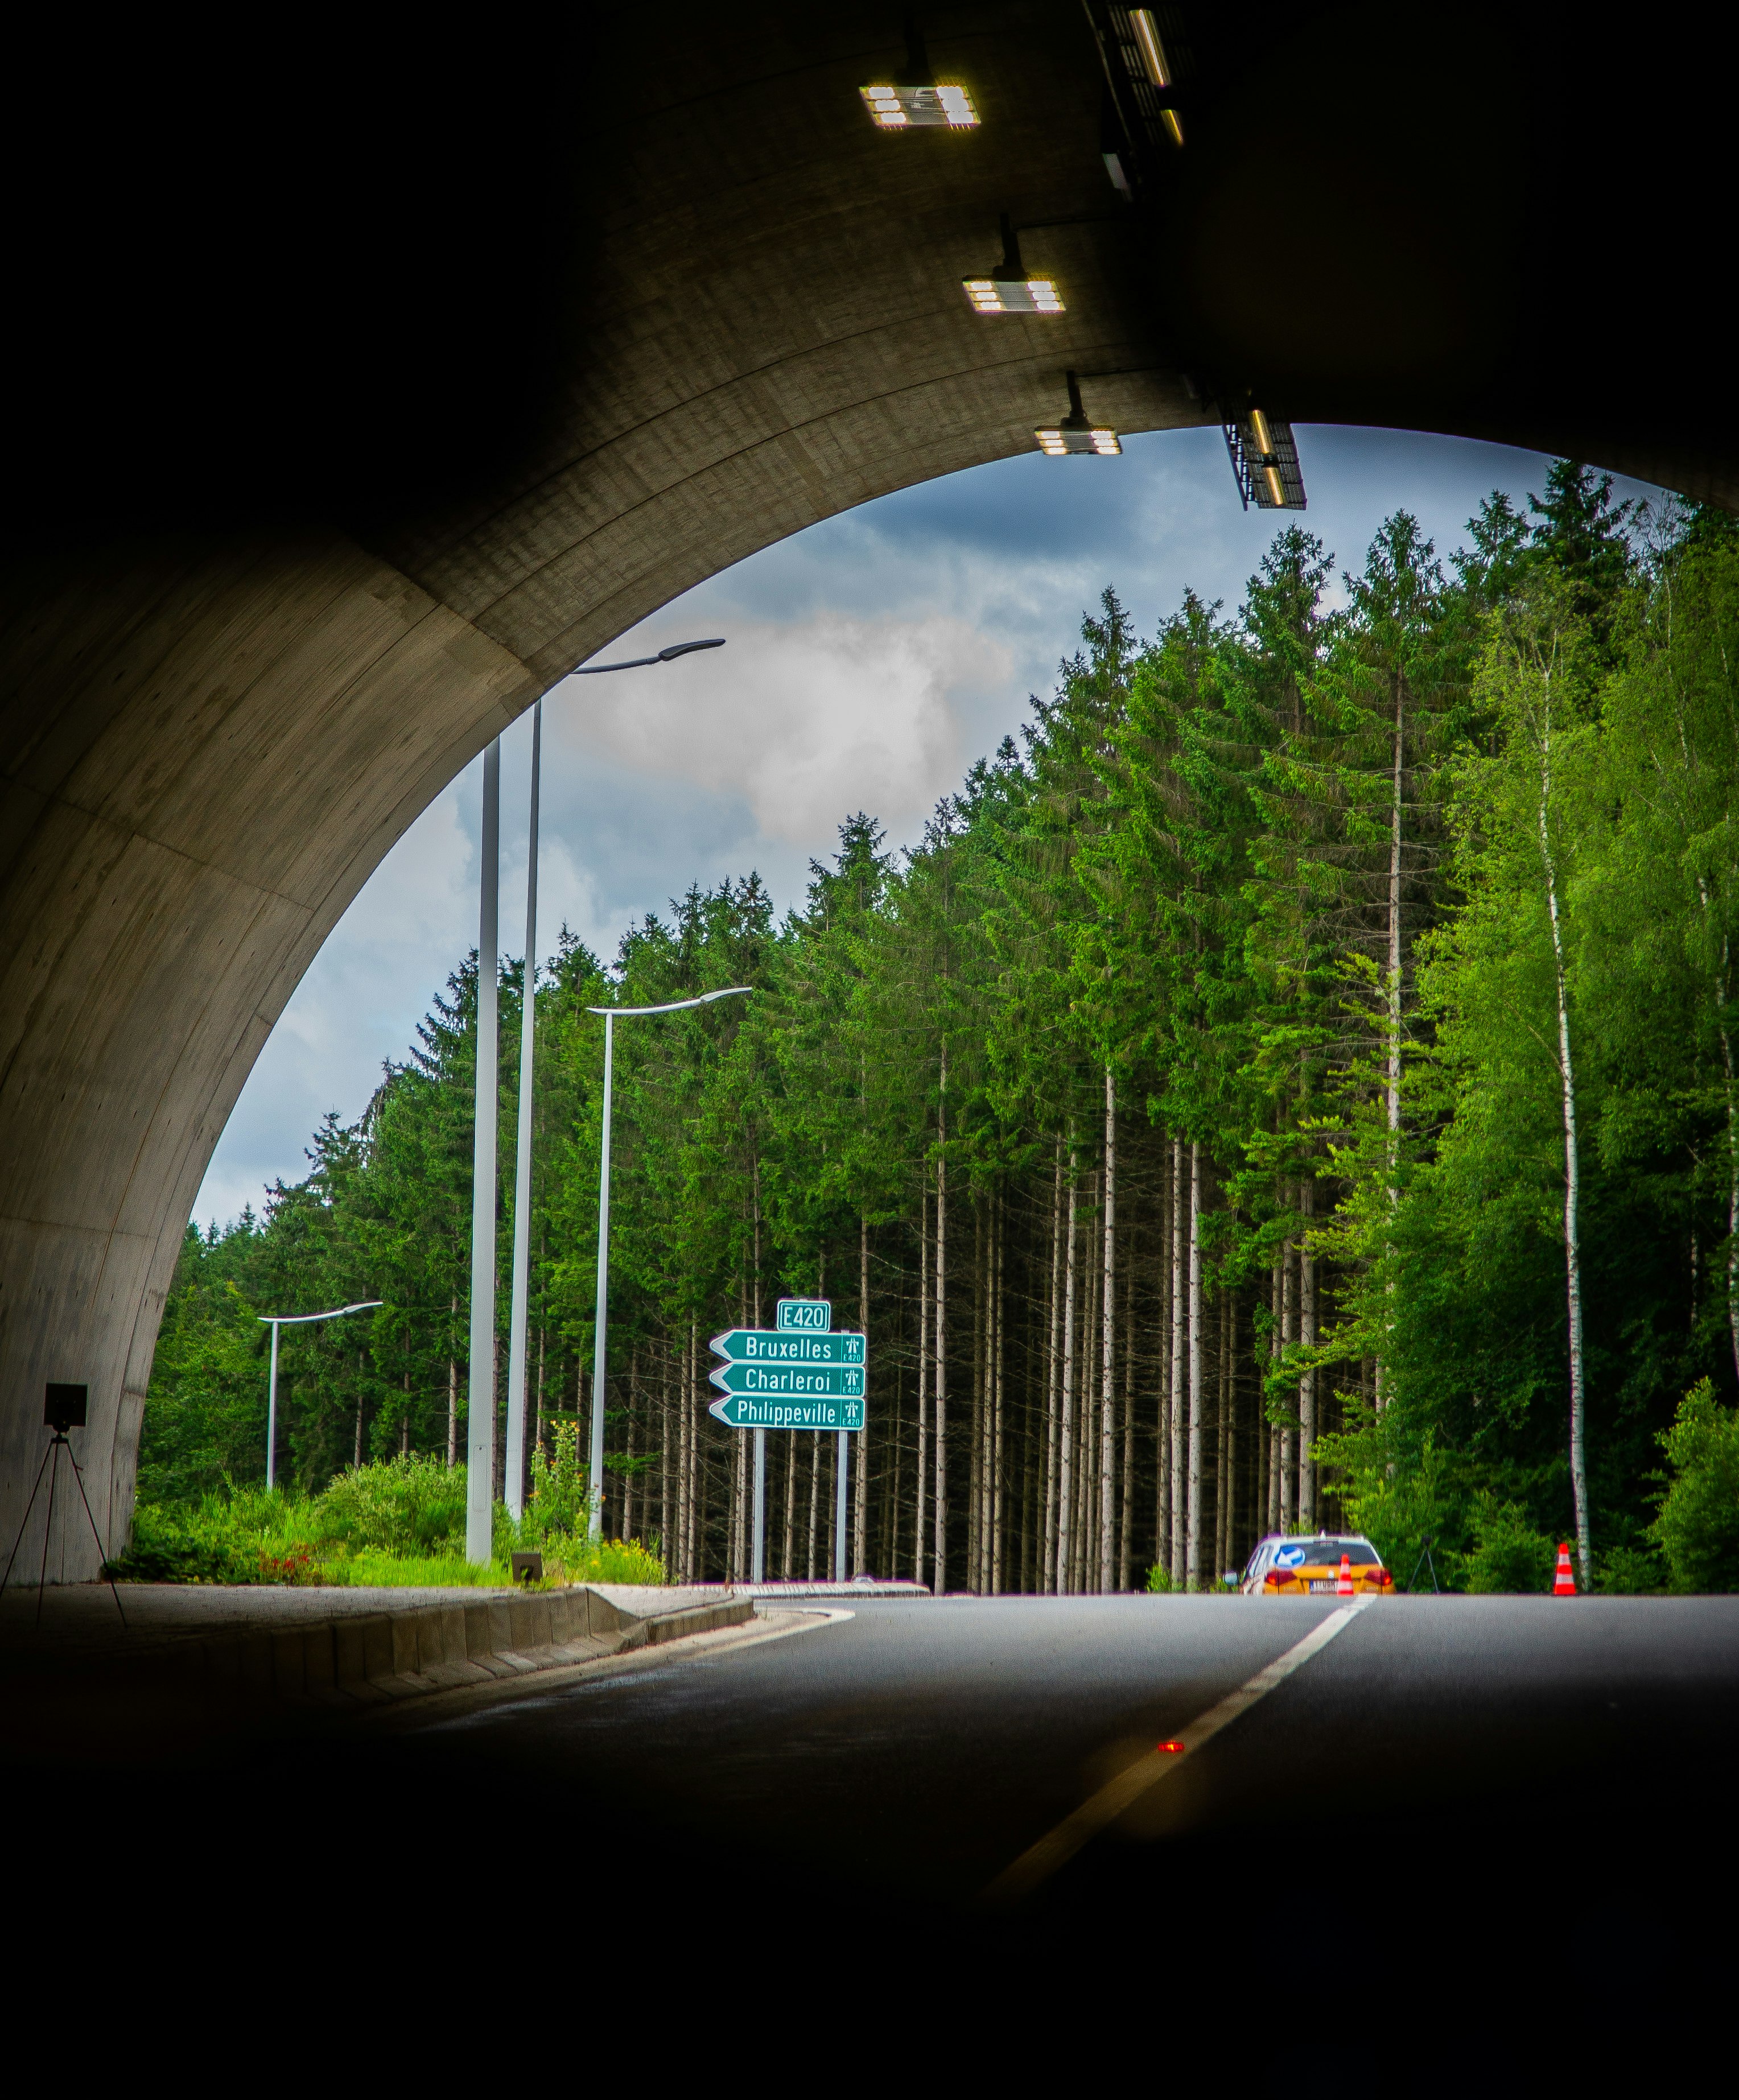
[0,0,1739,1577]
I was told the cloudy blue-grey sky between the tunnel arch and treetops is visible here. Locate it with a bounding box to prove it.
[193,424,1655,1227]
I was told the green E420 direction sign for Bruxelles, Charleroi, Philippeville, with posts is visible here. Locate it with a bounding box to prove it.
[708,1298,870,1583]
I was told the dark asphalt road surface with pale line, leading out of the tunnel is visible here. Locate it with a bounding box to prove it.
[78,1598,1739,2074]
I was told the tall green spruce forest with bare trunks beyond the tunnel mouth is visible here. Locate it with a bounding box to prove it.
[141,462,1739,1592]
